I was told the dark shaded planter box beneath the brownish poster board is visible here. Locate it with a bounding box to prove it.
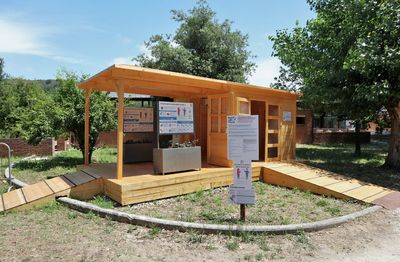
[124,139,153,164]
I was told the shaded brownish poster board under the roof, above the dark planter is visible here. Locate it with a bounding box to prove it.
[124,107,154,133]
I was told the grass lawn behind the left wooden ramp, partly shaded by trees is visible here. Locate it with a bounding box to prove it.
[1,147,117,184]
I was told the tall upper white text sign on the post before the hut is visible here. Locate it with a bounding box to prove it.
[227,115,259,162]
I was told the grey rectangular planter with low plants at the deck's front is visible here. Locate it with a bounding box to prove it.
[153,140,201,175]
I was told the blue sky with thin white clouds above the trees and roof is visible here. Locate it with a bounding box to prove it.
[0,0,315,86]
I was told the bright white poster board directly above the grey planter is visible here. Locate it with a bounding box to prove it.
[158,101,194,134]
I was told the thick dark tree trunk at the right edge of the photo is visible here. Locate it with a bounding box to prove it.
[385,102,400,170]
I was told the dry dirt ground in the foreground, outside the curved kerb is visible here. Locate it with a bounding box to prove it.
[0,205,400,262]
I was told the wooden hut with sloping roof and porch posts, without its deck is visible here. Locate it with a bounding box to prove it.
[79,65,298,180]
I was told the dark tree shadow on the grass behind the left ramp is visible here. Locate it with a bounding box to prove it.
[14,156,83,172]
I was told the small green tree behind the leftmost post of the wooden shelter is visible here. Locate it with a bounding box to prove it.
[54,70,116,162]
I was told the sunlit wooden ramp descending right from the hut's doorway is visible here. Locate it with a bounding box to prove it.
[263,162,400,208]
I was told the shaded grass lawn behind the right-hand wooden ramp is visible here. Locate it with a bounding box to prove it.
[296,140,400,190]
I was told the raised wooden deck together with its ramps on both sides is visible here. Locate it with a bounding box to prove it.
[0,162,400,212]
